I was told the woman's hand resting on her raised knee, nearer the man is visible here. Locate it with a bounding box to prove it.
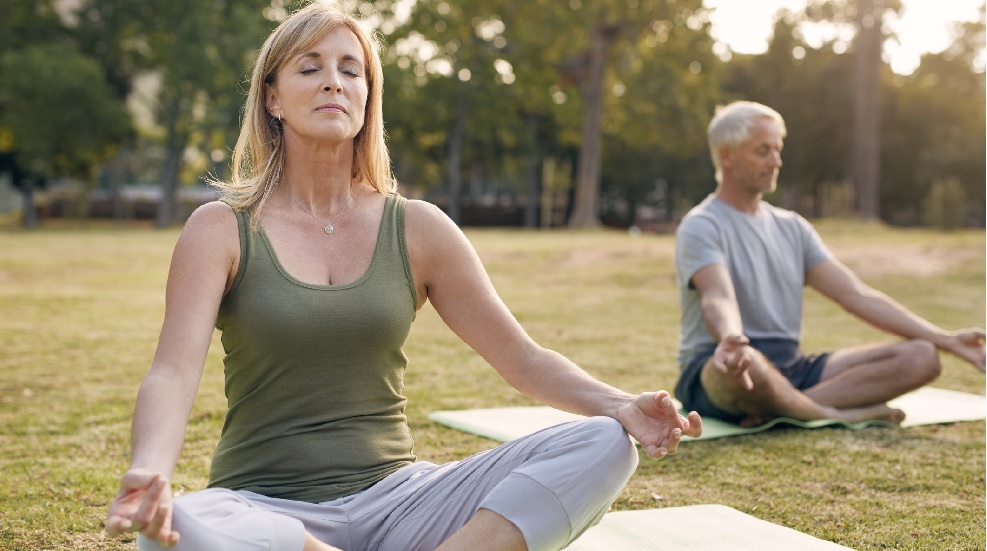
[616,390,703,459]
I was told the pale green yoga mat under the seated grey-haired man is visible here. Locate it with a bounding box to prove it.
[428,387,987,442]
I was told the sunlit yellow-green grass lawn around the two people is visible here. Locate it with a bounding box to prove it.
[0,221,985,551]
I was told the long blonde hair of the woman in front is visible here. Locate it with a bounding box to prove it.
[210,0,397,224]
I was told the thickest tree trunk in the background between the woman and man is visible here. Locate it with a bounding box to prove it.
[569,22,617,228]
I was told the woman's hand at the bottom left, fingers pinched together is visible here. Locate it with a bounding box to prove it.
[106,469,179,548]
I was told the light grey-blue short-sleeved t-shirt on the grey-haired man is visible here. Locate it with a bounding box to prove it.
[675,195,832,366]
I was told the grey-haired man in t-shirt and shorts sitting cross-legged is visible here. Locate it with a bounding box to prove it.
[675,102,985,426]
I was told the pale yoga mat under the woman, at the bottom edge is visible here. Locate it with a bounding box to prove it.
[566,505,853,551]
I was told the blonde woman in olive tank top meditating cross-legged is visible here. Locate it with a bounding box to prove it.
[107,2,702,551]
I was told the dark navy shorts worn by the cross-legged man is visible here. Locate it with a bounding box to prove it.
[675,339,829,423]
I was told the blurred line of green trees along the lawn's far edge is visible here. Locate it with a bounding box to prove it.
[0,0,987,231]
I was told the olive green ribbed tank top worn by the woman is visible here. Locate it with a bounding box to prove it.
[209,194,415,503]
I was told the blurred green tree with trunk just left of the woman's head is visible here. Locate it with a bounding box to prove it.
[124,0,272,226]
